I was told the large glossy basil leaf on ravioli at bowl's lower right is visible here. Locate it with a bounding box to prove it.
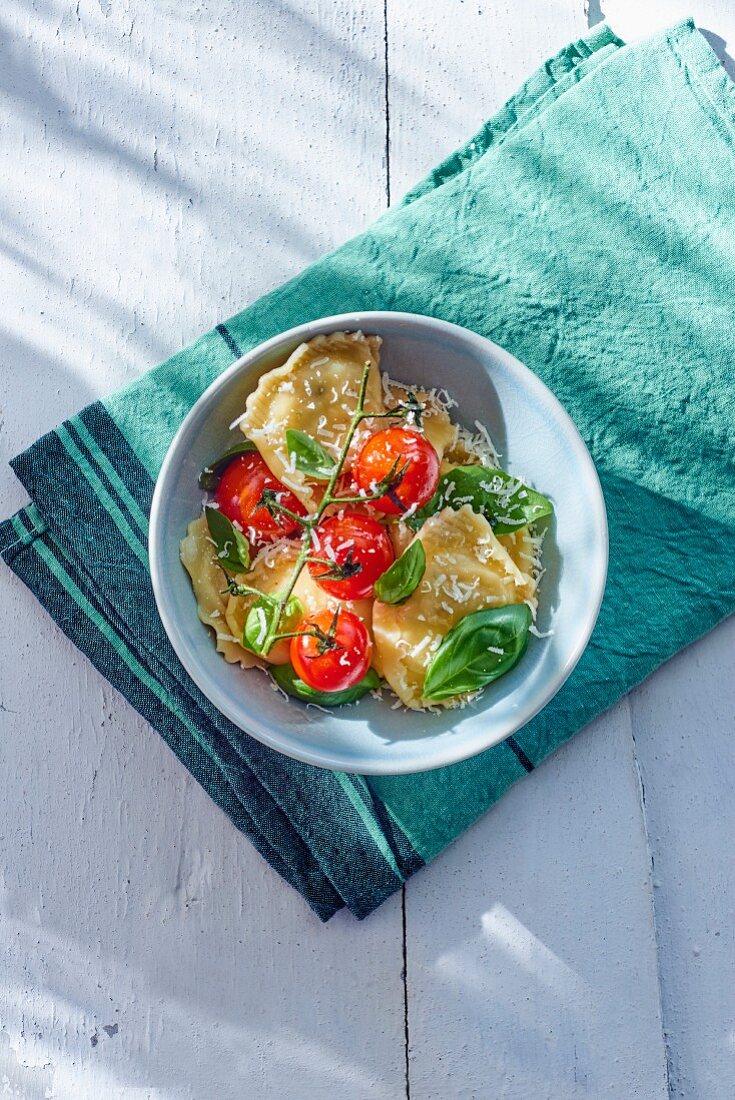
[424,604,533,700]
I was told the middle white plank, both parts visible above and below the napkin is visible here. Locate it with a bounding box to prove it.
[388,0,682,1100]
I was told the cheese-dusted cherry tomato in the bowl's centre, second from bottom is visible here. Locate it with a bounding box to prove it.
[309,512,395,600]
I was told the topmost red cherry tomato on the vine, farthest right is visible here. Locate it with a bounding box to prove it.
[353,428,439,516]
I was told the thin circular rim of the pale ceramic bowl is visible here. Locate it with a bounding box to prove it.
[149,310,610,776]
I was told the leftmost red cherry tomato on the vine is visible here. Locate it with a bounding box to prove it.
[215,451,306,542]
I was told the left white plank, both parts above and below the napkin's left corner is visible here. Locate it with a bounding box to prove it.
[0,0,405,1100]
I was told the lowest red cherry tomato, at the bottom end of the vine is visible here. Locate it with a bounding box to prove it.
[290,607,373,692]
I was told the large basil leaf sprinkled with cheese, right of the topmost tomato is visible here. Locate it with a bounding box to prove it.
[405,466,553,535]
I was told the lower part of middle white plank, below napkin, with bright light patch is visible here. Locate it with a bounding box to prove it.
[407,703,668,1100]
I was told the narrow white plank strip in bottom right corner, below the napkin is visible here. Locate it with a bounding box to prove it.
[630,619,735,1100]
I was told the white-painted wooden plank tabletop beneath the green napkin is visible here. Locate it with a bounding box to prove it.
[0,0,735,1100]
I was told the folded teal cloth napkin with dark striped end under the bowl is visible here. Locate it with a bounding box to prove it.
[0,22,735,920]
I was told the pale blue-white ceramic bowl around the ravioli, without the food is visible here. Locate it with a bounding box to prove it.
[150,312,607,774]
